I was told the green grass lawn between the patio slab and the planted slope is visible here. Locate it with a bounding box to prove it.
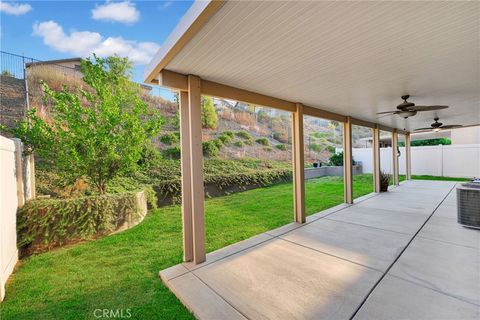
[0,174,464,320]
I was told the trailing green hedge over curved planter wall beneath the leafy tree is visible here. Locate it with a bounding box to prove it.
[17,192,146,255]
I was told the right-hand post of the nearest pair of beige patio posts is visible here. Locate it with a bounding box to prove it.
[188,75,205,264]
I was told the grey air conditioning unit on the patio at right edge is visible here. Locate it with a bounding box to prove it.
[457,179,480,229]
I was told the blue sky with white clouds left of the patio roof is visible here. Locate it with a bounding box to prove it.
[0,0,192,97]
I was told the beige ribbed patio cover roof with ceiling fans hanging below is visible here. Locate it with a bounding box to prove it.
[145,1,480,131]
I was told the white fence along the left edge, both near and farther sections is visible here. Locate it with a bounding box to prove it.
[0,136,35,301]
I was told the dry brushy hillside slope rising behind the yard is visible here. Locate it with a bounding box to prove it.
[28,67,352,163]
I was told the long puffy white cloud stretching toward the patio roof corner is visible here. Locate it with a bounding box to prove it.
[33,20,160,64]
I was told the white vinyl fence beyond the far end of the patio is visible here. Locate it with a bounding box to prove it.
[353,144,480,178]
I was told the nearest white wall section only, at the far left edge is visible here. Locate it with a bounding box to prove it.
[0,136,18,301]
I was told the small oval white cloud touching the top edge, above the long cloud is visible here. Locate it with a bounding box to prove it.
[92,0,140,24]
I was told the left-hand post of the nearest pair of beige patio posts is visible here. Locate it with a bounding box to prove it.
[179,91,193,262]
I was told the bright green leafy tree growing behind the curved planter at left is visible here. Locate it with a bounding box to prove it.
[12,56,163,194]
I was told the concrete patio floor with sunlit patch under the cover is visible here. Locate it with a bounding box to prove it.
[160,181,480,320]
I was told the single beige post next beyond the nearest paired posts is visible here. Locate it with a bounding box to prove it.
[292,103,305,223]
